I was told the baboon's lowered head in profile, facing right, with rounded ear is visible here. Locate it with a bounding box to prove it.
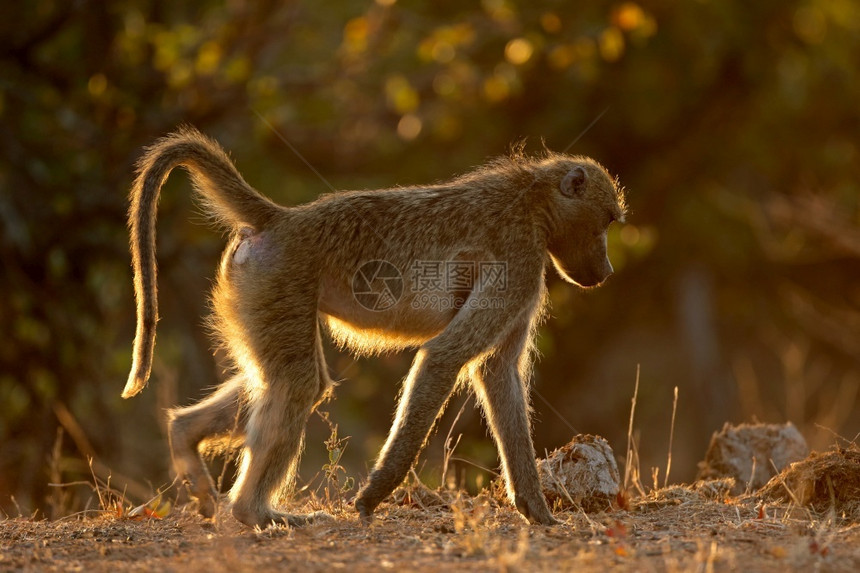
[542,156,625,287]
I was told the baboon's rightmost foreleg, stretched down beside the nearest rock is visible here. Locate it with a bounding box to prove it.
[472,320,558,525]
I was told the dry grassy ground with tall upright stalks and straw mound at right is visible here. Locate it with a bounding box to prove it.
[11,370,860,573]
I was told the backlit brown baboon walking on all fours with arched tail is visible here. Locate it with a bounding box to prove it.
[122,127,625,526]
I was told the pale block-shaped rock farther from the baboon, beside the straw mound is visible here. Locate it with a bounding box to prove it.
[697,422,809,495]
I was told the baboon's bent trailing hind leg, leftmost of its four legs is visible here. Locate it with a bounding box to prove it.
[167,376,245,517]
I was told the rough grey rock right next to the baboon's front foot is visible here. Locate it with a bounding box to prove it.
[538,434,621,513]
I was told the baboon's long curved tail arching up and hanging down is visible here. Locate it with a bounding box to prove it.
[122,127,281,398]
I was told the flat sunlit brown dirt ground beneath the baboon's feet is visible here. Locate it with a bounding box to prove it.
[0,486,860,573]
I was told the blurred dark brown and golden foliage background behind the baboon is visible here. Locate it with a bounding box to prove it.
[0,0,860,516]
